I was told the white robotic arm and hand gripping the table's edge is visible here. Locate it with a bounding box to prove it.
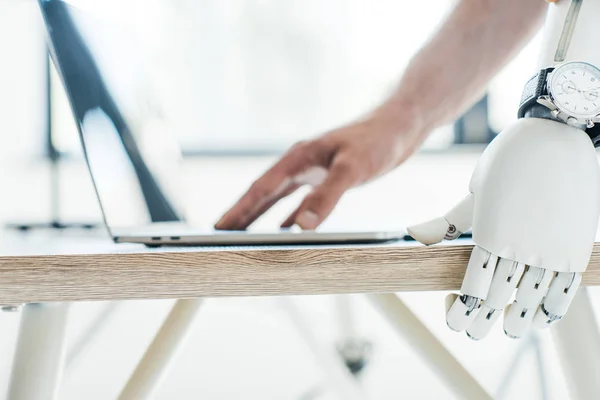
[408,0,600,339]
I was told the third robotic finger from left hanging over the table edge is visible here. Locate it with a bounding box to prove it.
[504,267,554,339]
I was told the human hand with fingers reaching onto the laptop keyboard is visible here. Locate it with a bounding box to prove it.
[215,107,424,230]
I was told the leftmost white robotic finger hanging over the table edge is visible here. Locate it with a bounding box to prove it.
[446,246,498,332]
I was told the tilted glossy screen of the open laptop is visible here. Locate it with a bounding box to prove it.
[39,0,183,229]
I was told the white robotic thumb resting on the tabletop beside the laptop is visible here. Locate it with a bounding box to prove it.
[407,193,475,245]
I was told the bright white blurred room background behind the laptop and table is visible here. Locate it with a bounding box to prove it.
[0,0,598,400]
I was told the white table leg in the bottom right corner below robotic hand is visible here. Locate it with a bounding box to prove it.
[551,288,600,400]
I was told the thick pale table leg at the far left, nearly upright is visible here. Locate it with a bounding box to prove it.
[8,303,69,400]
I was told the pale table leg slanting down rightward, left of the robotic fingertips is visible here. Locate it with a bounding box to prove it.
[367,293,492,400]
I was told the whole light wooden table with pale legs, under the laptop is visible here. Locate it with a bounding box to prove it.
[0,231,600,400]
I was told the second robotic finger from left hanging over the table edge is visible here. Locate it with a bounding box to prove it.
[467,259,525,340]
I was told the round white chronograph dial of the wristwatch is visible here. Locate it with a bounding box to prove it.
[548,62,600,118]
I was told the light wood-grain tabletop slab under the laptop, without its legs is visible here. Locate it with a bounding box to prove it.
[0,233,600,304]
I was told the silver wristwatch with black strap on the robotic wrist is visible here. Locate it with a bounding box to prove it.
[518,61,600,144]
